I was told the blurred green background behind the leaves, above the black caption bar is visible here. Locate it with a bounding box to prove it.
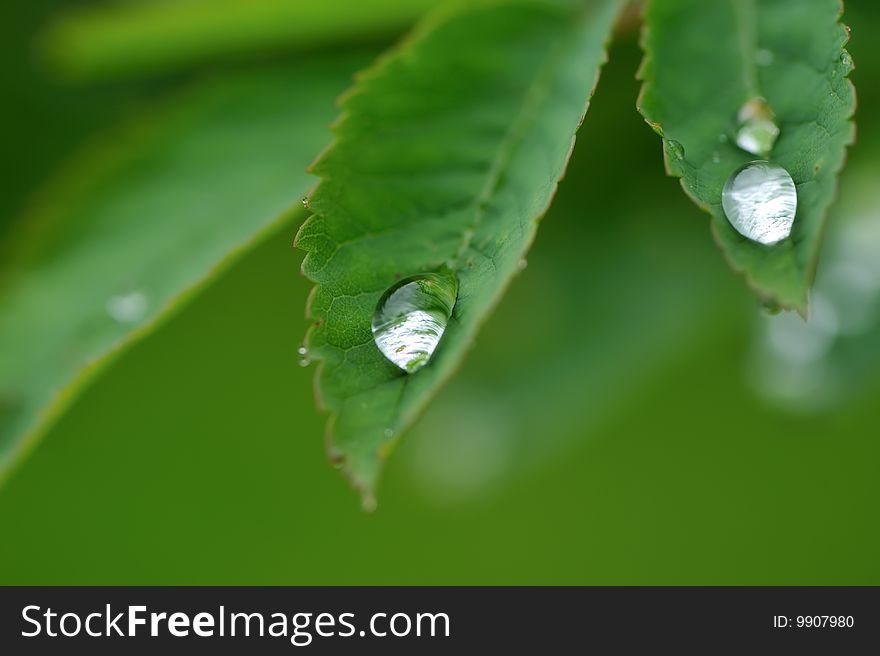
[0,1,880,584]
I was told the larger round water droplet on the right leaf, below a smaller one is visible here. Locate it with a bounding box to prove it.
[721,161,797,244]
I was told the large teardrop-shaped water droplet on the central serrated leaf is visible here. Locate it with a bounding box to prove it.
[372,271,458,373]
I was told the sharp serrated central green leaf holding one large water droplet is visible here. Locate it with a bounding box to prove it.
[297,0,619,504]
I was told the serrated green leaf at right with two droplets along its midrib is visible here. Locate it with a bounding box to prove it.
[639,0,855,312]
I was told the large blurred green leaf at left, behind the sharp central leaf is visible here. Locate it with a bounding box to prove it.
[0,58,363,482]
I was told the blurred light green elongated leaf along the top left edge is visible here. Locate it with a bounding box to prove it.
[40,0,438,80]
